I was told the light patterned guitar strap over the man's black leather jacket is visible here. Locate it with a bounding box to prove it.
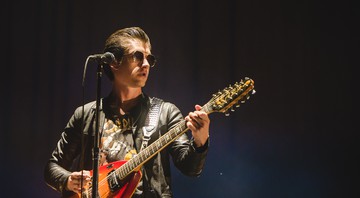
[140,98,163,151]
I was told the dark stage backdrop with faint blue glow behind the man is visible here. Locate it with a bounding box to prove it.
[0,0,360,198]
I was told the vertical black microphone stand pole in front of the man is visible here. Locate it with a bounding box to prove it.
[92,61,103,198]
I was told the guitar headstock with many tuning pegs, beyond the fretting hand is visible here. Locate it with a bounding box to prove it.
[204,77,255,115]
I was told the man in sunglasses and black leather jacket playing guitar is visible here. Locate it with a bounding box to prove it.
[44,27,210,197]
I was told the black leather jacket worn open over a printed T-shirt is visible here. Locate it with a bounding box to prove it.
[44,94,208,197]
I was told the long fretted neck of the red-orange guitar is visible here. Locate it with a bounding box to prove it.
[116,104,210,179]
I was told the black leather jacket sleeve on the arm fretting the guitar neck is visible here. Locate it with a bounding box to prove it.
[164,103,209,177]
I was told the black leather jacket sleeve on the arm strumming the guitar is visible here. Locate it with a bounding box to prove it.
[44,108,82,193]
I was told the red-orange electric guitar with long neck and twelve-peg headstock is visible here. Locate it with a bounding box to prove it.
[68,78,255,198]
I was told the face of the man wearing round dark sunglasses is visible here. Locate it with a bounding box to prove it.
[111,40,151,88]
